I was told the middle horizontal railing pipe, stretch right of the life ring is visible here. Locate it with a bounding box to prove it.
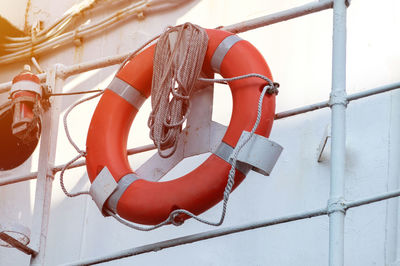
[275,82,400,120]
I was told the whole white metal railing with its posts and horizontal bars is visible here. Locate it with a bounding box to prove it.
[0,0,400,266]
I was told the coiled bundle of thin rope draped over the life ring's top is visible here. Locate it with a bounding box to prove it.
[148,23,208,158]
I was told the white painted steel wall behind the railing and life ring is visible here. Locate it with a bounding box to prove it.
[0,0,400,266]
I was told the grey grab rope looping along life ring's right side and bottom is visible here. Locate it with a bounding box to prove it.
[105,74,279,231]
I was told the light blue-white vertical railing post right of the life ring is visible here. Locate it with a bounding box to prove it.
[328,0,347,266]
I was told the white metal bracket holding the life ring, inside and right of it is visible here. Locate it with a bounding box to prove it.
[135,85,282,181]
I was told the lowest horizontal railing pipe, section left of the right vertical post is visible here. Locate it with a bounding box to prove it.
[64,208,327,266]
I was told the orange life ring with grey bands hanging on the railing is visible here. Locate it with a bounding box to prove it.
[86,29,275,225]
